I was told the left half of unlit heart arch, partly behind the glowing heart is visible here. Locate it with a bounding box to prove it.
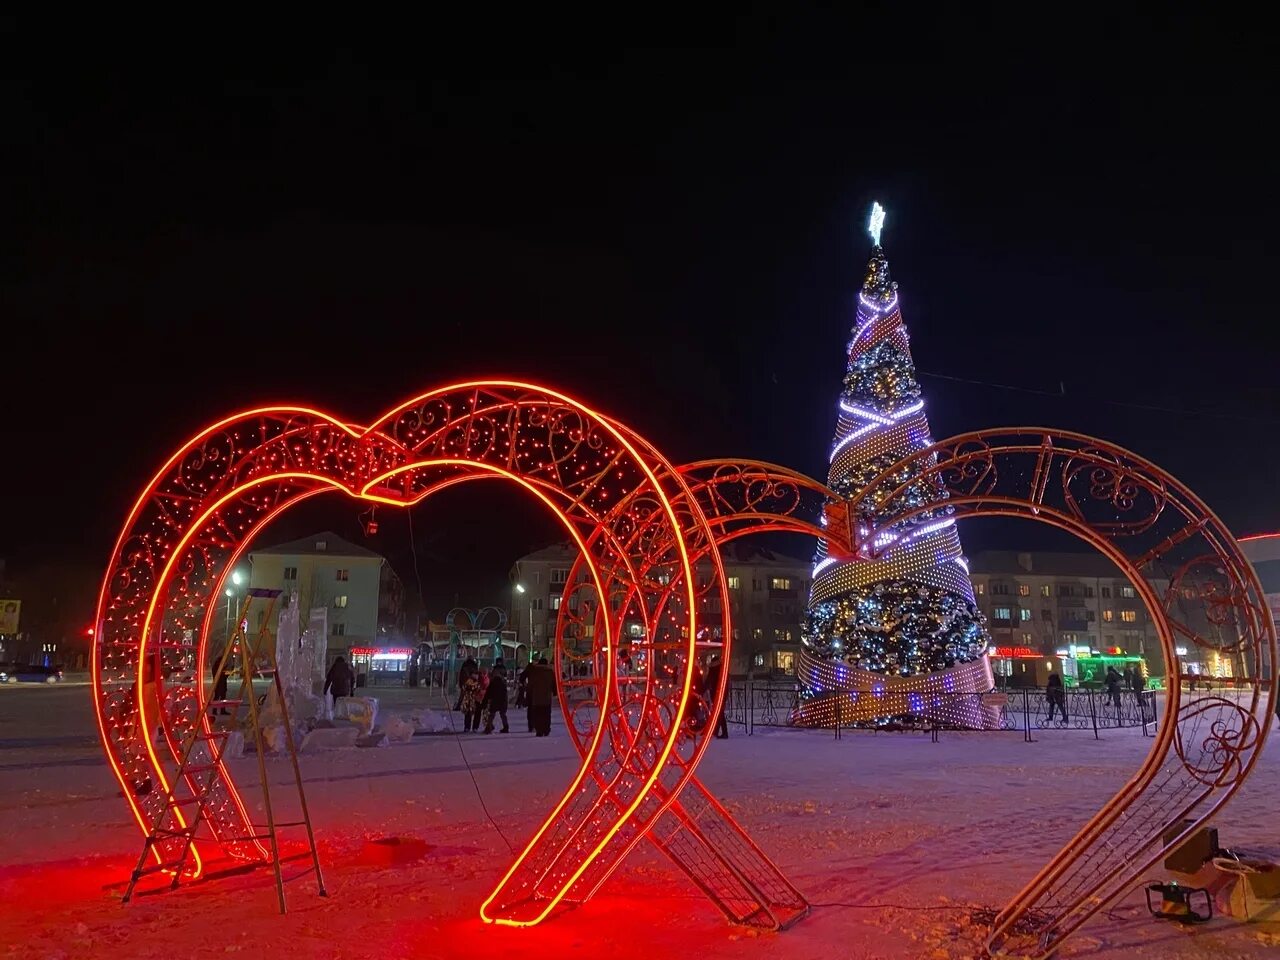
[556,460,849,929]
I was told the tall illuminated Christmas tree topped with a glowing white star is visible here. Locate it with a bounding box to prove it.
[795,204,992,726]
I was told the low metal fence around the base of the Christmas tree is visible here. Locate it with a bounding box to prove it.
[724,681,1156,742]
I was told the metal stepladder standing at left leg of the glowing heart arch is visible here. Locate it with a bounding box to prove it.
[123,588,328,914]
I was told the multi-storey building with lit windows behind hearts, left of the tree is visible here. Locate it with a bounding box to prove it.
[511,540,812,677]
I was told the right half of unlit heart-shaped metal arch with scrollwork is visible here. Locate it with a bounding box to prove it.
[849,428,1277,957]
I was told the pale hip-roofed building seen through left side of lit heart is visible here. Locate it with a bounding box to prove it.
[244,531,404,660]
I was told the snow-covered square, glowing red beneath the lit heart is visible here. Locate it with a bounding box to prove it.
[0,685,1280,960]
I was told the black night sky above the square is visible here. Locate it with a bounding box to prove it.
[0,5,1280,614]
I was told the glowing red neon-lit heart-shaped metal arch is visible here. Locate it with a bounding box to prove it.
[92,380,747,925]
